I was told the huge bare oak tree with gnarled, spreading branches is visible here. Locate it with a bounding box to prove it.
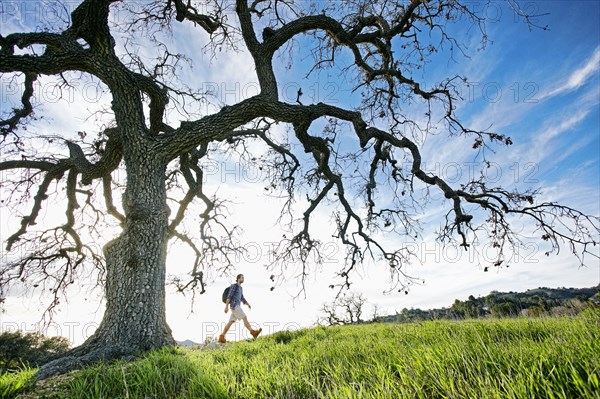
[0,0,598,378]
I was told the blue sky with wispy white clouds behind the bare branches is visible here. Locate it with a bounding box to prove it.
[0,1,600,342]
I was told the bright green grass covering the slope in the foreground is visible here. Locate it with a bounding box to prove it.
[5,310,600,399]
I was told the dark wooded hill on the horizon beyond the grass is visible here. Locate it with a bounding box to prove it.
[373,286,600,323]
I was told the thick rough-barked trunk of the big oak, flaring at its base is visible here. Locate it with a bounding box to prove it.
[37,153,175,379]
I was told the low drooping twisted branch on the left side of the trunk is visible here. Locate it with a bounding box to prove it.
[0,130,124,318]
